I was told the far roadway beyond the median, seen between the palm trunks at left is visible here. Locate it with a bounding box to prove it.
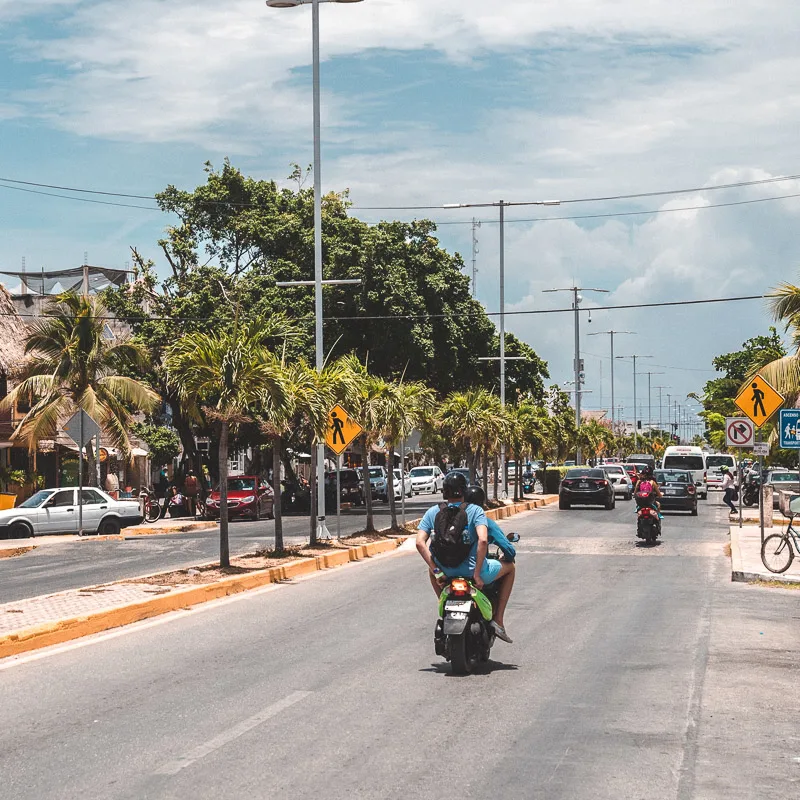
[0,495,437,603]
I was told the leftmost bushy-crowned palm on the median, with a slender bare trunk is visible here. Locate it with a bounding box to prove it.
[165,321,285,567]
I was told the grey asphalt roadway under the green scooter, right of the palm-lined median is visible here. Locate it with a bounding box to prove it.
[0,495,800,800]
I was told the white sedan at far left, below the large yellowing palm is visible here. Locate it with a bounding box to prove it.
[0,487,142,539]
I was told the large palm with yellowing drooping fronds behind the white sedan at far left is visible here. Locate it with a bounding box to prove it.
[0,292,159,481]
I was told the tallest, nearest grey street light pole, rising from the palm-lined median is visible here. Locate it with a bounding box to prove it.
[266,0,362,538]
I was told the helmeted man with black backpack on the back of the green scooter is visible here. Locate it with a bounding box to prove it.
[417,472,515,644]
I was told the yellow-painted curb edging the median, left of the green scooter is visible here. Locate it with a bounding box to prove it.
[0,538,405,659]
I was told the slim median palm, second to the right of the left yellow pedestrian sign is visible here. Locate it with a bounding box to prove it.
[378,381,435,528]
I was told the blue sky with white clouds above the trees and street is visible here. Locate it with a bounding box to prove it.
[0,0,800,424]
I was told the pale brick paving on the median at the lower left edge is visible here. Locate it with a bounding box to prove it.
[0,583,178,636]
